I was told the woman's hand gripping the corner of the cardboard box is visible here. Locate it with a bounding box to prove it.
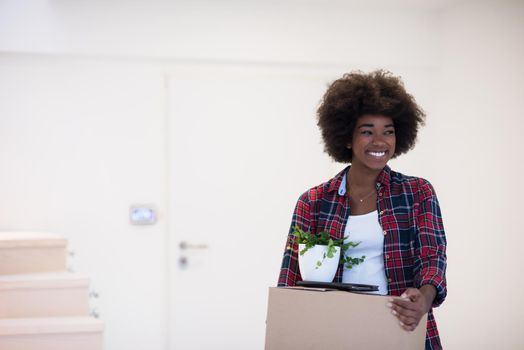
[387,285,437,332]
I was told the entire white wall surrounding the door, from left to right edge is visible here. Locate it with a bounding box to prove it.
[0,0,524,350]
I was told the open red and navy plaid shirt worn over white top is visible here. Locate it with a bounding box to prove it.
[278,166,446,350]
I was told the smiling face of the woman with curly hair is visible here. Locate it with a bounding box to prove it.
[348,114,396,171]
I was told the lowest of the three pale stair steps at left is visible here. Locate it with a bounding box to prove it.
[0,317,104,350]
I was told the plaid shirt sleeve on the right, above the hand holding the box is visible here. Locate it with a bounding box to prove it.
[414,179,447,307]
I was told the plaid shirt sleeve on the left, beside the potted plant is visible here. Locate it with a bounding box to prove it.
[278,192,311,287]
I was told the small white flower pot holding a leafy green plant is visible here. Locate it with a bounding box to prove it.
[298,244,340,282]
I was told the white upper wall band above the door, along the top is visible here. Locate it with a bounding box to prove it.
[0,0,438,67]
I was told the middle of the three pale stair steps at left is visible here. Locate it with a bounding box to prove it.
[0,272,89,318]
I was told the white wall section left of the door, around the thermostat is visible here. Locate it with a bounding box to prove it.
[0,56,166,349]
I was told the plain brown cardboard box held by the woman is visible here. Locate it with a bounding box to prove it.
[265,287,427,350]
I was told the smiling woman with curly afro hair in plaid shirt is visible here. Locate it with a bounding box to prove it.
[278,70,446,349]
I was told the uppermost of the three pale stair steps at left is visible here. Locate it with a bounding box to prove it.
[0,232,67,275]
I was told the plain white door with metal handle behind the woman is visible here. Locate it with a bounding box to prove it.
[168,68,333,350]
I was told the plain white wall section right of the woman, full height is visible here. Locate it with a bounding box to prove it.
[432,1,524,349]
